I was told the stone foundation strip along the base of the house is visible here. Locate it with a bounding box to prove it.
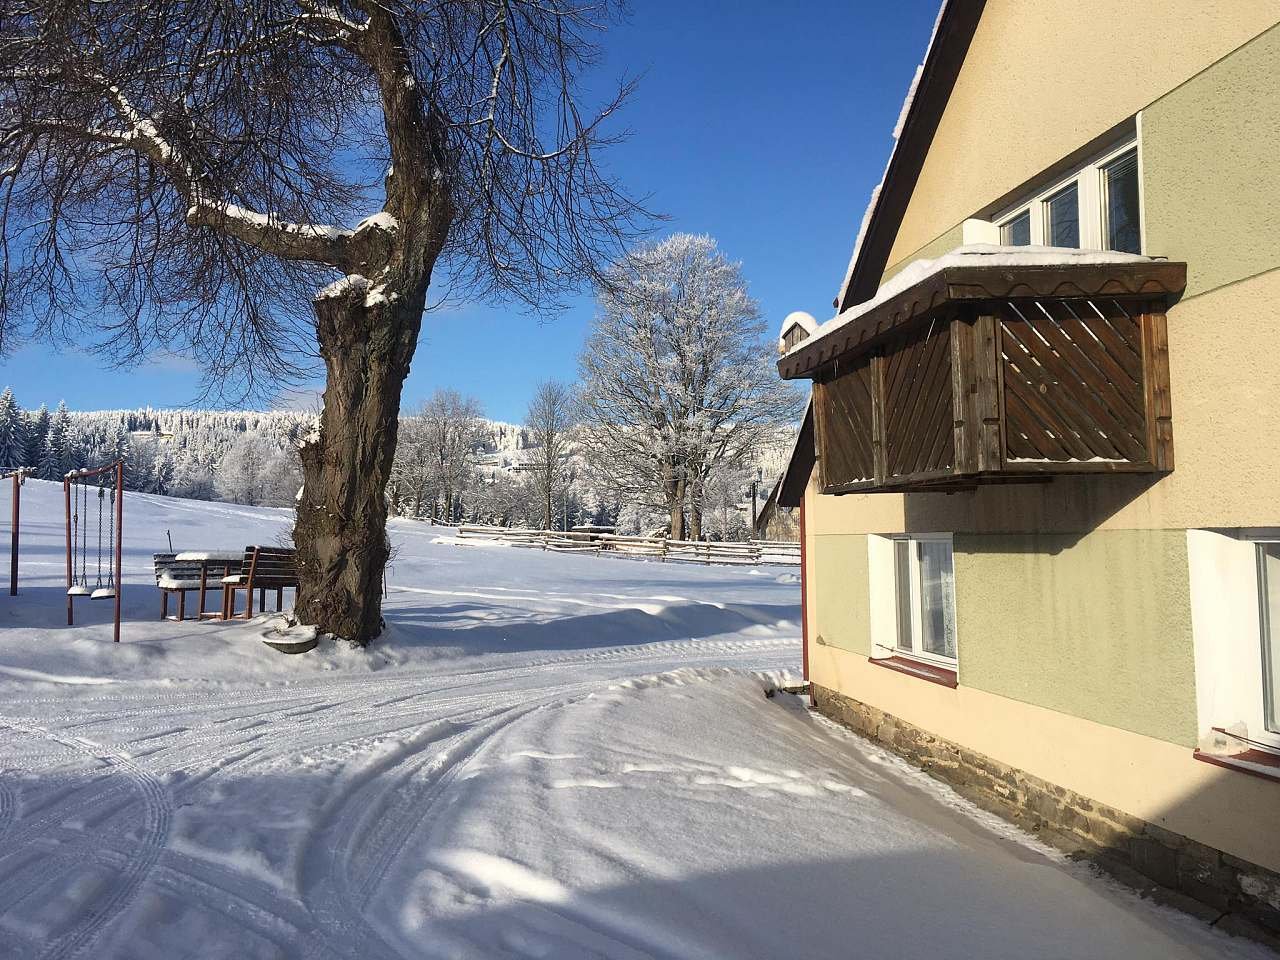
[812,684,1280,950]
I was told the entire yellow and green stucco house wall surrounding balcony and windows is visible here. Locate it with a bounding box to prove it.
[805,0,1280,921]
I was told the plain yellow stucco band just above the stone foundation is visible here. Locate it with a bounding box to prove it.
[809,640,1280,870]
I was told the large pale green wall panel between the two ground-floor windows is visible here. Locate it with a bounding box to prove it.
[955,530,1197,746]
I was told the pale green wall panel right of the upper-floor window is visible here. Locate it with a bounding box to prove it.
[1142,26,1280,297]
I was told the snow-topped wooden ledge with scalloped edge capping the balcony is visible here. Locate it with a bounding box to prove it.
[778,244,1187,380]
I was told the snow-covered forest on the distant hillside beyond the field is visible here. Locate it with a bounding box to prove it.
[0,388,791,539]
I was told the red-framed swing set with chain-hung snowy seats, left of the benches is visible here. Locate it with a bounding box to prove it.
[63,460,124,643]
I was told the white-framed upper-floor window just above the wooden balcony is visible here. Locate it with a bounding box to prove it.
[996,143,1142,253]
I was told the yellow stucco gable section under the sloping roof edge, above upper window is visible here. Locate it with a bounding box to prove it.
[888,0,1280,264]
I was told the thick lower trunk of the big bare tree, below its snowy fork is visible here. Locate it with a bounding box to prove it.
[293,273,429,645]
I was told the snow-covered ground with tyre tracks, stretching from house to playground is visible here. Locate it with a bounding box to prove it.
[0,481,1271,960]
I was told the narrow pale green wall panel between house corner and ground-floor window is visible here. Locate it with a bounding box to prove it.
[808,534,872,657]
